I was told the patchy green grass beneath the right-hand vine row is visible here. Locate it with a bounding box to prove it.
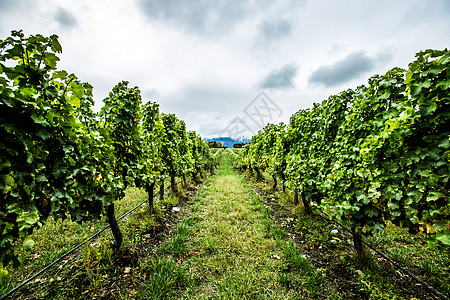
[244,164,450,299]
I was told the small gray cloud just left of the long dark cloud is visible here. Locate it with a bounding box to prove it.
[260,63,298,89]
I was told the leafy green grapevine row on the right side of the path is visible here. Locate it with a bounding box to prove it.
[242,50,450,253]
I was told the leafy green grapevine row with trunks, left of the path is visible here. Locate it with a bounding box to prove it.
[0,31,216,279]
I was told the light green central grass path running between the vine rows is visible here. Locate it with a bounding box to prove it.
[185,164,289,299]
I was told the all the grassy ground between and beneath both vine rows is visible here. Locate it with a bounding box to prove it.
[0,149,450,299]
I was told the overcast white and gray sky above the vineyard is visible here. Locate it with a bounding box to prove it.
[0,0,450,137]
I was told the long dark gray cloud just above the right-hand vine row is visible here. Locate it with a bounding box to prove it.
[309,49,393,86]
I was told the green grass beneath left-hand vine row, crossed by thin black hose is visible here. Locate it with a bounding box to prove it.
[0,175,198,299]
